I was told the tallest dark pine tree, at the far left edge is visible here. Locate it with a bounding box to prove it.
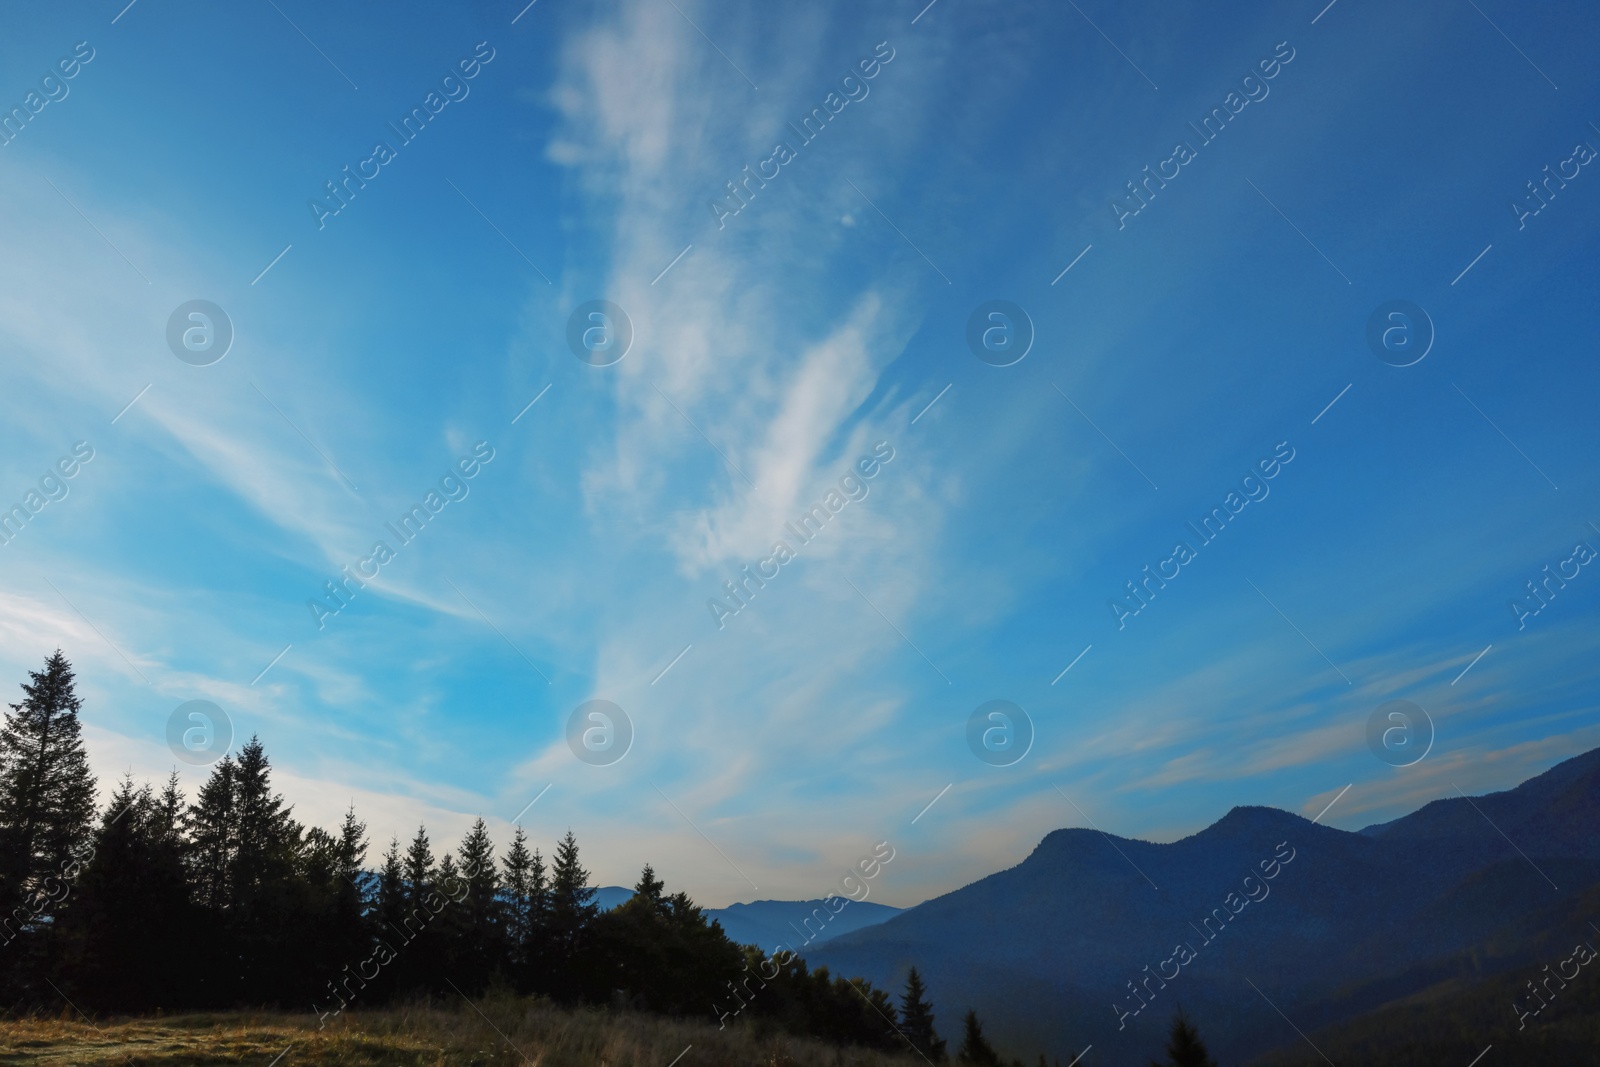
[0,648,94,937]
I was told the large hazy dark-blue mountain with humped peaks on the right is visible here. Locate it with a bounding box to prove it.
[806,750,1600,1064]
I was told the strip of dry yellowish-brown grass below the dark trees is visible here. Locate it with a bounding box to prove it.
[0,997,923,1067]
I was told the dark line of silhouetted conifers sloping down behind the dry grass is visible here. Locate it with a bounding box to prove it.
[0,649,1209,1067]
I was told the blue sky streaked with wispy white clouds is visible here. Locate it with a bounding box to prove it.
[0,0,1600,905]
